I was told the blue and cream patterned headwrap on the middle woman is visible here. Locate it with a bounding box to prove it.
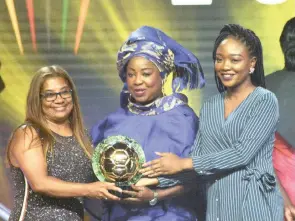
[117,26,205,105]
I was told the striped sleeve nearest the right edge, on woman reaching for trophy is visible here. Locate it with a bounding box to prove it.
[192,93,279,175]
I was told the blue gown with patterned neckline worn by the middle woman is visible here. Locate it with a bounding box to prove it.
[92,94,202,221]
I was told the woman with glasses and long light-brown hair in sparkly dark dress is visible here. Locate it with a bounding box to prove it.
[7,66,121,221]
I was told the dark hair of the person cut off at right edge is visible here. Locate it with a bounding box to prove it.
[280,18,295,71]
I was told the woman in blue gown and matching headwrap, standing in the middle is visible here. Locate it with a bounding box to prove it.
[91,26,205,221]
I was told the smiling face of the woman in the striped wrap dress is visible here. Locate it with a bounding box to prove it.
[215,37,256,89]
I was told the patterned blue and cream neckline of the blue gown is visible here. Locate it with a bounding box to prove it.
[127,93,187,116]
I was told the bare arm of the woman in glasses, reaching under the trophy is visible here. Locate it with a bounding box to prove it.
[8,128,121,200]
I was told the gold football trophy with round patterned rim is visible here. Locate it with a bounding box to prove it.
[92,135,145,198]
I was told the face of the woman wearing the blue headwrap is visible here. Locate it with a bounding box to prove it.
[126,57,162,104]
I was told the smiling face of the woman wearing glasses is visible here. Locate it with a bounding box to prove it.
[41,77,73,123]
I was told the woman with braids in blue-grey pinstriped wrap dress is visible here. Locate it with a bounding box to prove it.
[142,24,283,221]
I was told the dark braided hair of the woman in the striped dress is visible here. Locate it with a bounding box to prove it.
[213,24,265,92]
